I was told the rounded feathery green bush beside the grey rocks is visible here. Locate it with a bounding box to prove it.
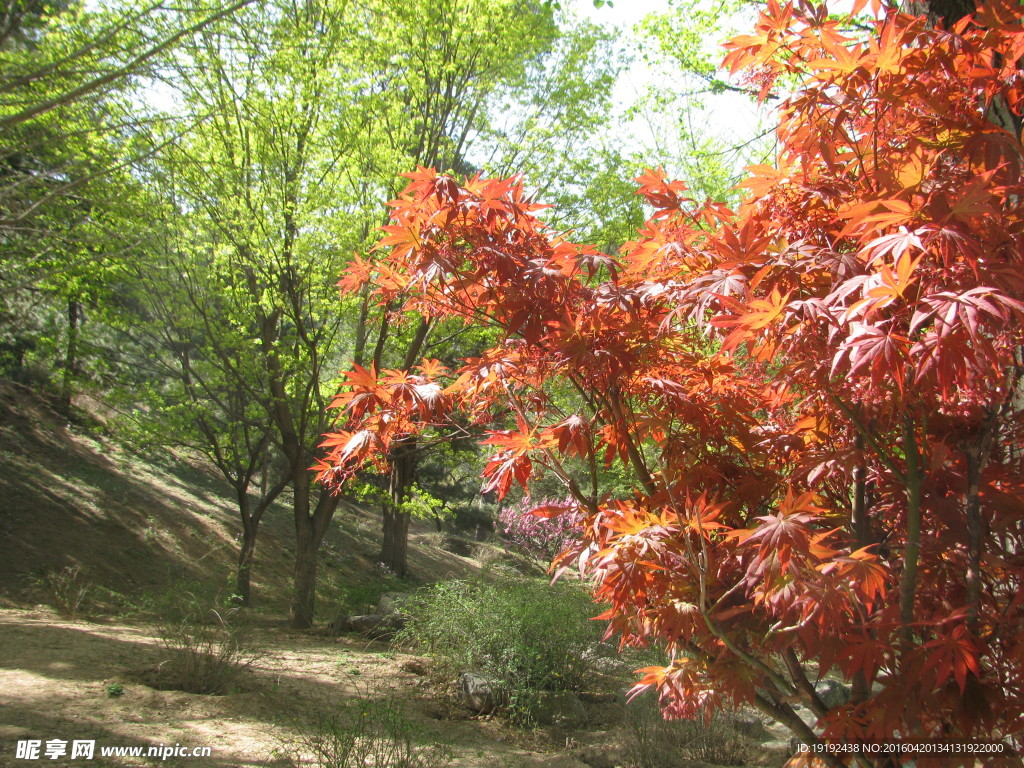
[398,577,602,691]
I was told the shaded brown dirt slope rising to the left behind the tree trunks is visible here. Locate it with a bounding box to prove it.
[0,381,475,622]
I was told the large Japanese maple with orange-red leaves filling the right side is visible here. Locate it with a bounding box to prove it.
[319,0,1024,764]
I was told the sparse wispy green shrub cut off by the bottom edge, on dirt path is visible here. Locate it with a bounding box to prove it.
[292,696,452,768]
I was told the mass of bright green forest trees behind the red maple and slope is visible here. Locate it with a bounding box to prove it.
[0,0,765,626]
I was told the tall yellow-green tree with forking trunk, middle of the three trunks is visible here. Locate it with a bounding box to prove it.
[152,0,369,627]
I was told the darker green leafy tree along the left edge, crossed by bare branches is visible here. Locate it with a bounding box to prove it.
[0,0,251,410]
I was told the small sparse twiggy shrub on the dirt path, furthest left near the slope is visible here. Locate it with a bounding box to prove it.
[156,593,261,694]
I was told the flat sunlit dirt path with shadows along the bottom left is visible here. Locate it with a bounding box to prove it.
[0,610,598,768]
